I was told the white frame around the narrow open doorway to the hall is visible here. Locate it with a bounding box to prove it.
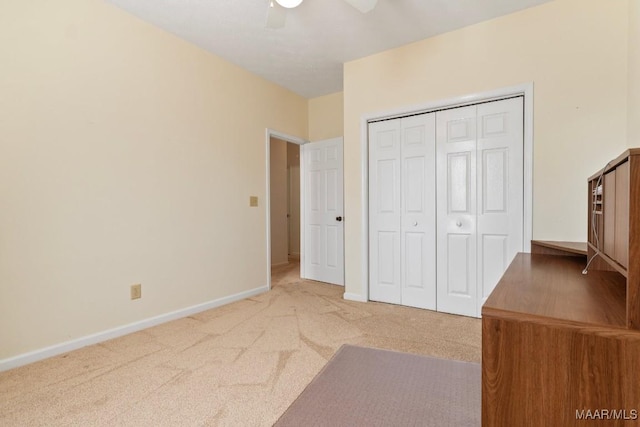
[264,128,309,290]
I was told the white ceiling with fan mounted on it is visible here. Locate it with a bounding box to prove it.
[107,0,550,98]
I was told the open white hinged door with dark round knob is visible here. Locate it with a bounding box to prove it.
[302,138,344,286]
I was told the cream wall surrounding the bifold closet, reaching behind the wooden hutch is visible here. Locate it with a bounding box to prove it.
[344,0,628,294]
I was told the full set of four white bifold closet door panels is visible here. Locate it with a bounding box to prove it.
[369,97,524,317]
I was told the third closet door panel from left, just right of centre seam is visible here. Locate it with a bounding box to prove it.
[436,105,477,316]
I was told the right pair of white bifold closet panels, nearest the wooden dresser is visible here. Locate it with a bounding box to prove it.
[436,97,524,317]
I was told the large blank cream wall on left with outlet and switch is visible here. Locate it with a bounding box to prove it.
[0,0,308,361]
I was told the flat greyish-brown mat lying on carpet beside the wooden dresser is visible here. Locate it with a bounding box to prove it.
[276,344,481,427]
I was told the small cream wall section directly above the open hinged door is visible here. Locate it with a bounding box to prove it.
[309,92,344,141]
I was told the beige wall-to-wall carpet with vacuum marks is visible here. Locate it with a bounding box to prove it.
[0,264,481,426]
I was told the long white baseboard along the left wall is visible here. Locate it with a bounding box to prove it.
[0,286,269,372]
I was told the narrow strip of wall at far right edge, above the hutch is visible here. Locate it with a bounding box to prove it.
[627,0,640,147]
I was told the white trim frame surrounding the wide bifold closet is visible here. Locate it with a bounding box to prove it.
[358,82,533,302]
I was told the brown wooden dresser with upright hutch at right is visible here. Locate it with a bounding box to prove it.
[482,149,640,427]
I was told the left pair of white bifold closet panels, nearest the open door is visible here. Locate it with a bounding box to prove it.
[369,113,436,310]
